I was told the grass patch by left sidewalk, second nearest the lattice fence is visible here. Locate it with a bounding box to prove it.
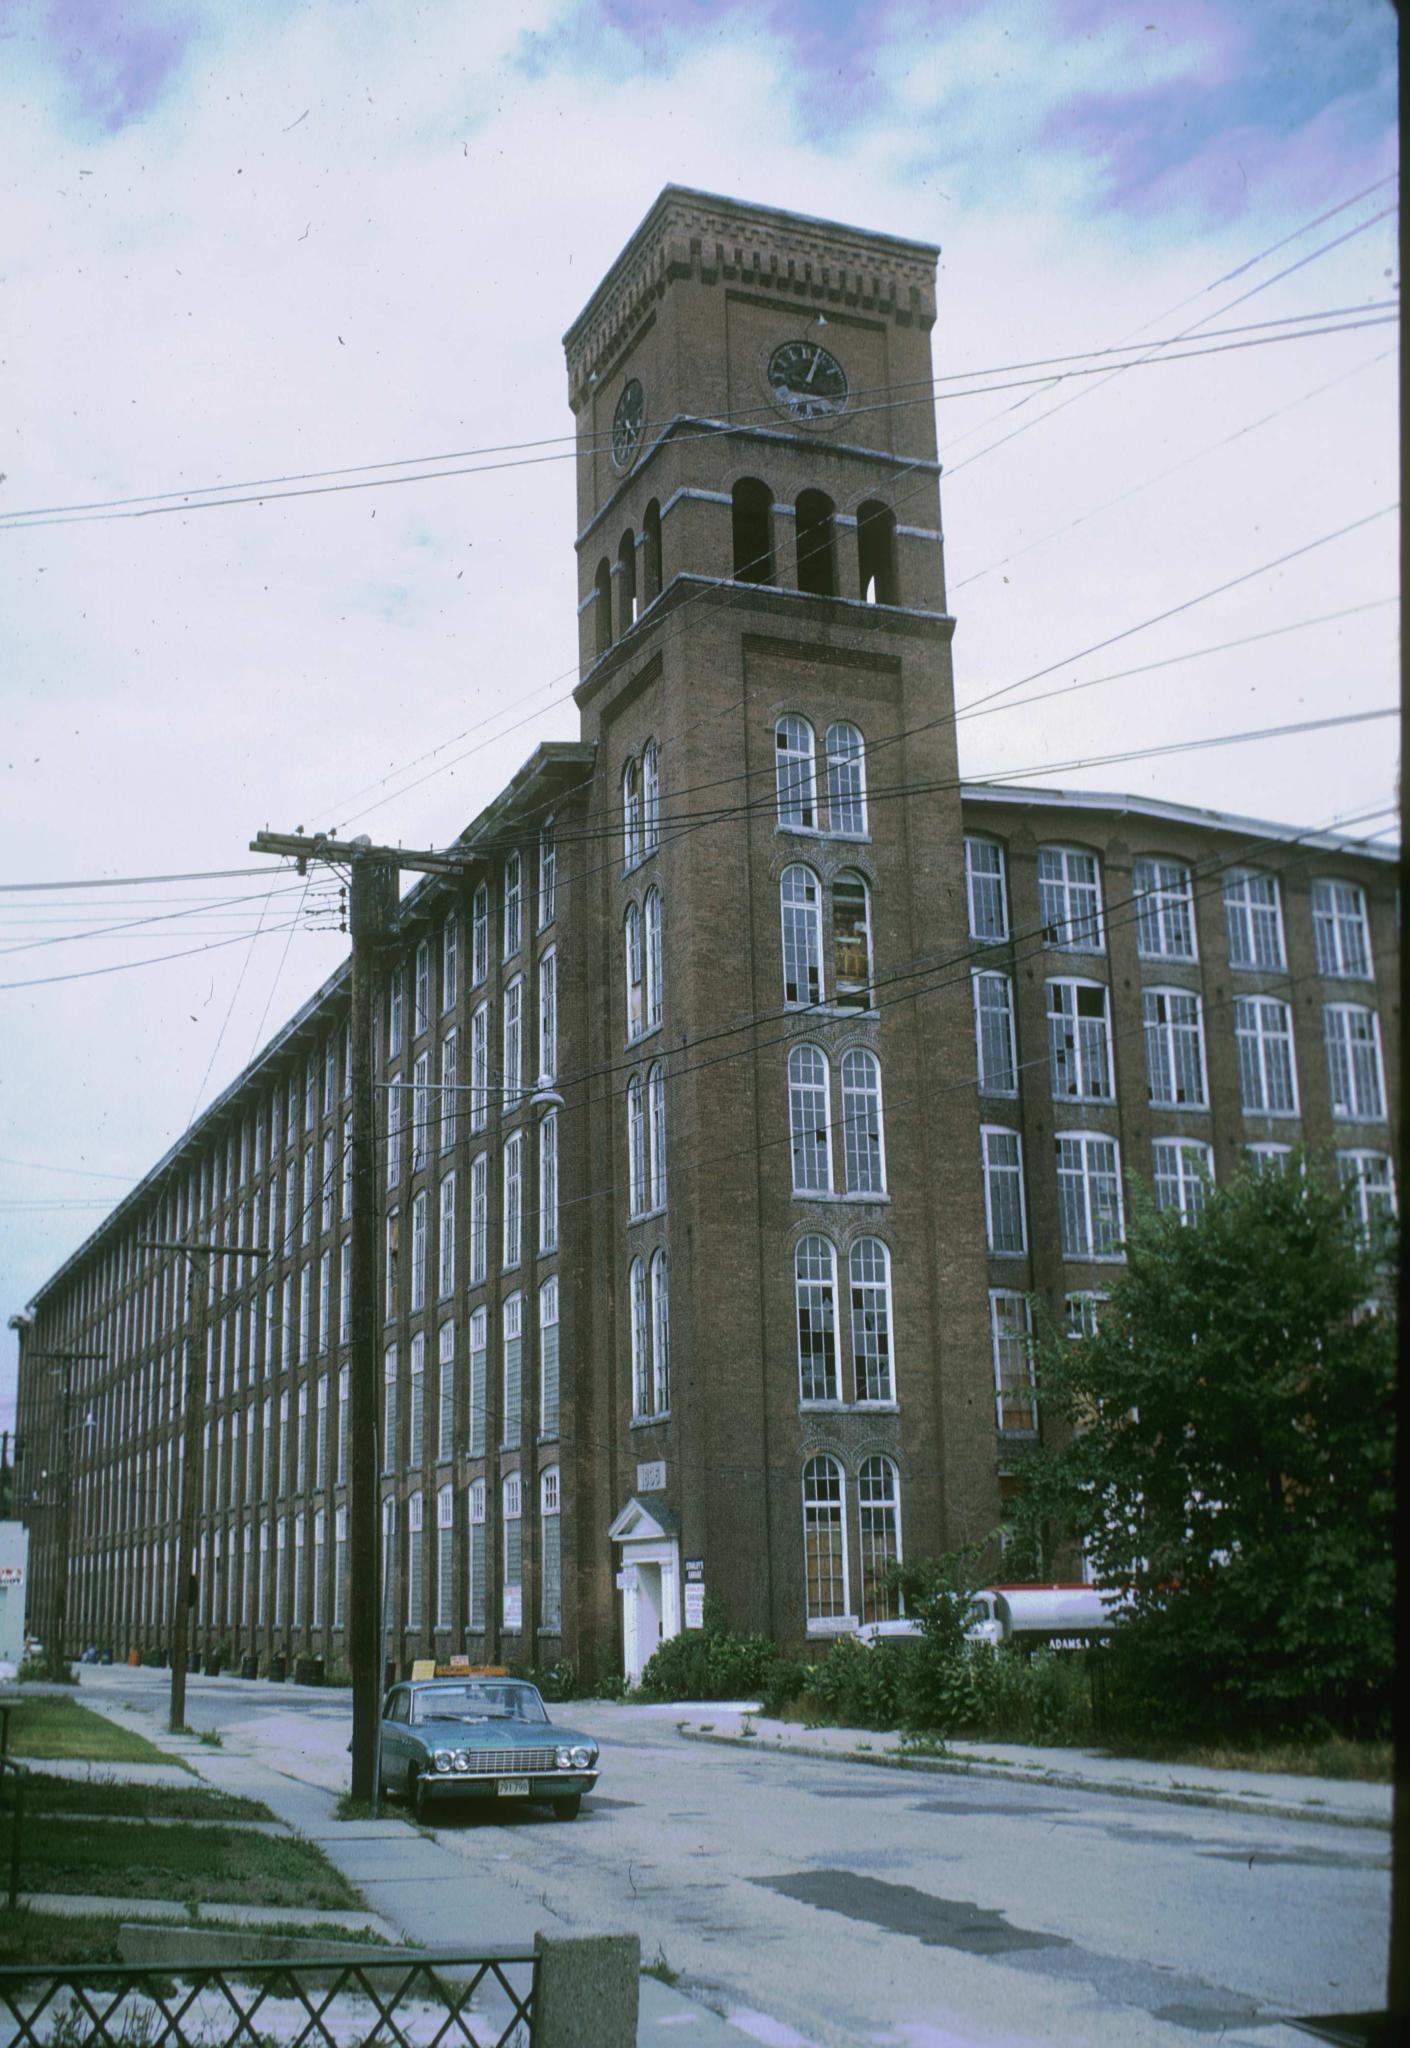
[0,1819,361,1909]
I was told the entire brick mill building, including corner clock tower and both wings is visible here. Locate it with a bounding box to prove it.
[16,186,1398,1675]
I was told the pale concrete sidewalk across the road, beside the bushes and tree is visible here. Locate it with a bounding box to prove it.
[654,1702,1392,1829]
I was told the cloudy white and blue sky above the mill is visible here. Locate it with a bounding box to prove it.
[0,0,1400,1427]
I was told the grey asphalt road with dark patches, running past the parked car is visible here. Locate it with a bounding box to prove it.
[84,1671,1390,2048]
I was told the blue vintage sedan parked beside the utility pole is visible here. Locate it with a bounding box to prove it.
[379,1673,598,1821]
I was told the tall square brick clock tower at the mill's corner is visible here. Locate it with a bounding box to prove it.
[566,186,998,1671]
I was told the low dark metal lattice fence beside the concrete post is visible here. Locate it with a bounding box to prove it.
[0,1948,537,2048]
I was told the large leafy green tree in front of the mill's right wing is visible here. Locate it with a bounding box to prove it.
[1025,1161,1396,1735]
